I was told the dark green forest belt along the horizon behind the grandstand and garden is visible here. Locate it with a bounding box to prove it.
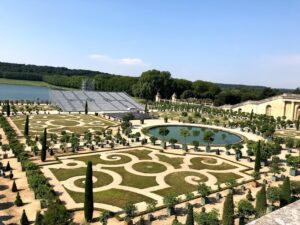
[0,62,300,105]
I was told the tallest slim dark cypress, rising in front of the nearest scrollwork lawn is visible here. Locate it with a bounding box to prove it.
[84,161,94,222]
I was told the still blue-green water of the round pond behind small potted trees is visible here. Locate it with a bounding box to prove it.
[149,125,242,145]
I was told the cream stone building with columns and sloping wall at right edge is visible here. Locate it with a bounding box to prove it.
[220,94,300,120]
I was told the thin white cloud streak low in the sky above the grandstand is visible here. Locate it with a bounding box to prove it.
[89,54,146,66]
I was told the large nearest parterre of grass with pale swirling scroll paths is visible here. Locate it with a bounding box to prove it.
[43,147,251,212]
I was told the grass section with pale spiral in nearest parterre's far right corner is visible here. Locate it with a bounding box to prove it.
[190,157,236,170]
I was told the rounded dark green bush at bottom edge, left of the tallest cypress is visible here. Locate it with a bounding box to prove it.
[44,203,70,225]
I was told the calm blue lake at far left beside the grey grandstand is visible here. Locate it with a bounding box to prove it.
[0,84,49,100]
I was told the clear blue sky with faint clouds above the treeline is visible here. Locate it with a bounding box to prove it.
[0,0,300,88]
